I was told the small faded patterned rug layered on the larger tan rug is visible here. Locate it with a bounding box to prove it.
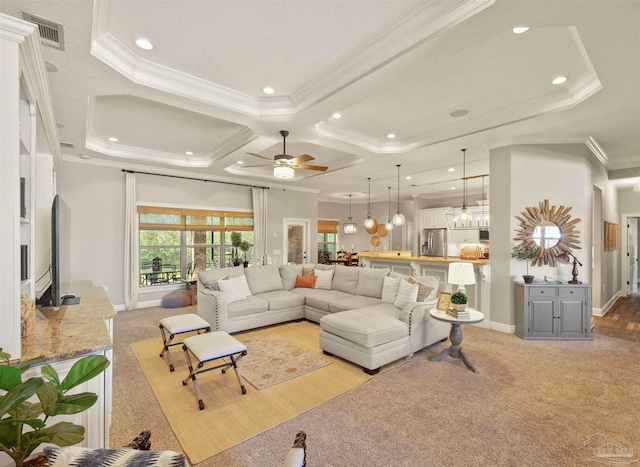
[239,332,331,390]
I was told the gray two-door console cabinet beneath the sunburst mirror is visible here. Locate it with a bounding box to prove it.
[515,282,591,339]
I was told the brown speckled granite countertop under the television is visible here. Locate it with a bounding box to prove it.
[21,281,116,362]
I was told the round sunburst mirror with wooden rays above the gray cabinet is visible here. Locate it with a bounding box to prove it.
[514,199,580,266]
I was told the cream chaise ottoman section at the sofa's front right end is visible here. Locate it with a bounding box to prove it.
[320,303,411,374]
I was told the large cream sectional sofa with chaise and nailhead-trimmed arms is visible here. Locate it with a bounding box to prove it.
[198,264,449,373]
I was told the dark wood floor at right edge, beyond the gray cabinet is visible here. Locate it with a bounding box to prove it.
[591,294,640,342]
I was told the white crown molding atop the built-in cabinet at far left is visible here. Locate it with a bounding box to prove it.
[0,14,62,165]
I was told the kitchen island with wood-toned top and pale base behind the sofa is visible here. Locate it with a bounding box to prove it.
[358,250,491,322]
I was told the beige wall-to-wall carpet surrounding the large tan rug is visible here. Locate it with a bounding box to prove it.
[111,307,640,467]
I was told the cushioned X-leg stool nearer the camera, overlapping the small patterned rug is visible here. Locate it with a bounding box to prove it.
[182,331,247,410]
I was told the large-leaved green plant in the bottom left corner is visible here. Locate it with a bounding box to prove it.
[0,348,110,467]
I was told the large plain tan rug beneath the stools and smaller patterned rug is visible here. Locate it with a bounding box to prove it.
[131,321,370,464]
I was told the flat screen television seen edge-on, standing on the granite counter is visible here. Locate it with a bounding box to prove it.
[38,195,78,307]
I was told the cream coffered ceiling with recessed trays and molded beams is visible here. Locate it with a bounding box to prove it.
[0,0,640,201]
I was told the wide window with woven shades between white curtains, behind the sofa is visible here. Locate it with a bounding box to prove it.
[138,206,253,286]
